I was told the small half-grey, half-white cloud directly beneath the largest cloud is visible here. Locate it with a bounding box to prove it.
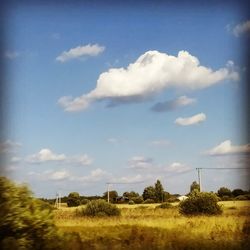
[151,95,196,112]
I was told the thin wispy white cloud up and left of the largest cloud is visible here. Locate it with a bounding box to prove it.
[56,44,105,63]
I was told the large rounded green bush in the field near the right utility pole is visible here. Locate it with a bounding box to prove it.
[179,192,222,215]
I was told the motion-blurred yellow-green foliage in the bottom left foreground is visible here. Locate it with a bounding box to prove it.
[0,177,62,249]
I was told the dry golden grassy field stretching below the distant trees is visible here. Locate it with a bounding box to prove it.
[55,201,250,250]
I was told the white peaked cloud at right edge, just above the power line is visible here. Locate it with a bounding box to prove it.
[206,140,250,156]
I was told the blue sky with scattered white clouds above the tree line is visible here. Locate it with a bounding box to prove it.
[1,2,249,197]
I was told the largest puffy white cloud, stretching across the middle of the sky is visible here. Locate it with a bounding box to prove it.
[58,51,239,112]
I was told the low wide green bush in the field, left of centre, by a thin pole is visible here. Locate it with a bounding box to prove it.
[83,200,121,216]
